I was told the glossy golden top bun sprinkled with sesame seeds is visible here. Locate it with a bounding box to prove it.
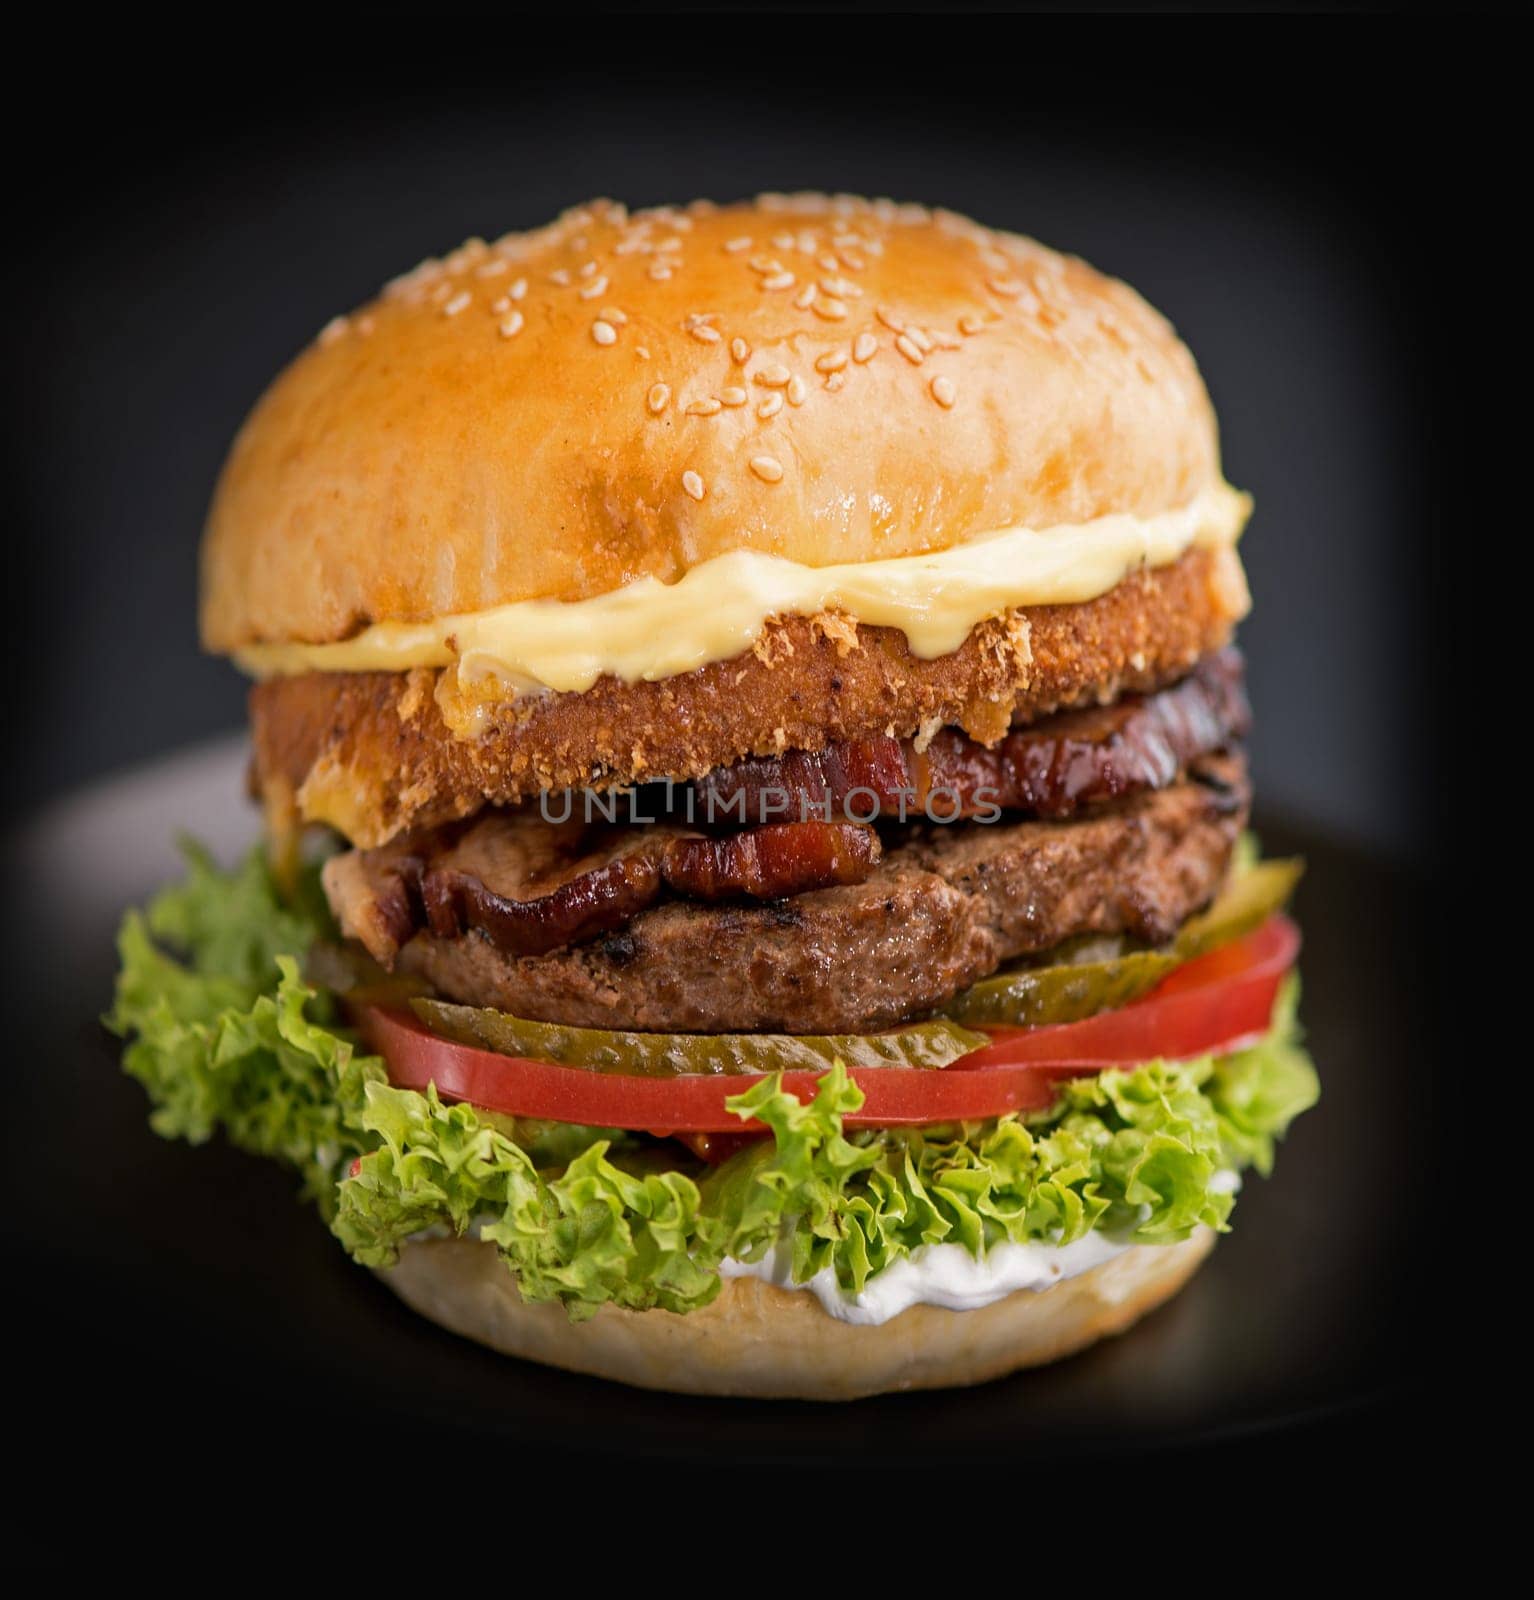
[202,195,1219,651]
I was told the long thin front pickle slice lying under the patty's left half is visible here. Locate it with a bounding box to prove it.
[411,998,990,1078]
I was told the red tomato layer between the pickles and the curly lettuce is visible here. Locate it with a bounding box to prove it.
[355,917,1299,1144]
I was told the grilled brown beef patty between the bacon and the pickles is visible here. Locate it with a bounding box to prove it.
[380,754,1249,1034]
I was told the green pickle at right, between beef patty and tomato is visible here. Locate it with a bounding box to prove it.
[944,859,1305,1027]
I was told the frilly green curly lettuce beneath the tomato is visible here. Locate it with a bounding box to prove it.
[106,848,1318,1318]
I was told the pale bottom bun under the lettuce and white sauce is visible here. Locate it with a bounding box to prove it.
[379,1229,1214,1400]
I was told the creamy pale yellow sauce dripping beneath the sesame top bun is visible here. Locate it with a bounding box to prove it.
[235,483,1251,698]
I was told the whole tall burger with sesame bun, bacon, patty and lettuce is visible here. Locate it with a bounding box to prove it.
[109,195,1316,1400]
